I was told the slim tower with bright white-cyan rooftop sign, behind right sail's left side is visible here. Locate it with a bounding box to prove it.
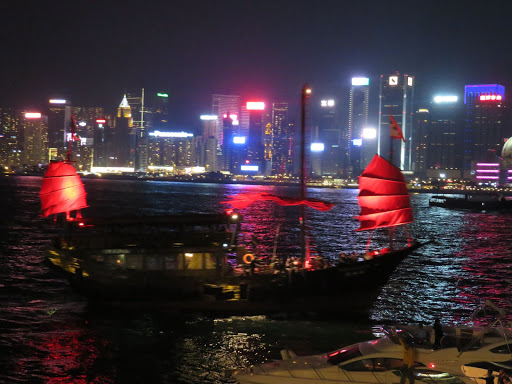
[350,77,375,177]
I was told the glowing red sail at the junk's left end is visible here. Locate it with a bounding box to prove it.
[40,161,87,217]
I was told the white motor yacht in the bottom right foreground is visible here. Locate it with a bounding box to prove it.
[233,300,512,384]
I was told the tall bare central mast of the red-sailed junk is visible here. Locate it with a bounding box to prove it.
[300,83,311,261]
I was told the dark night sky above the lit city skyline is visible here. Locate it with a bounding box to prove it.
[0,0,512,125]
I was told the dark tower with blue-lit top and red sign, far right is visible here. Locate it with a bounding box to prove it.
[464,84,511,181]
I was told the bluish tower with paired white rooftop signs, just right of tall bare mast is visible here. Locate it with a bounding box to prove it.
[312,99,343,176]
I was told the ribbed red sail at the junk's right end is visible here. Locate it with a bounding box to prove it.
[357,155,413,231]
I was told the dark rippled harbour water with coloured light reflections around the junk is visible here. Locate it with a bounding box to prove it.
[0,177,512,383]
